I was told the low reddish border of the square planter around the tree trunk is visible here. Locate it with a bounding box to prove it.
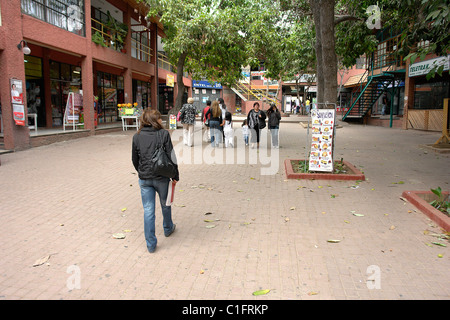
[284,159,366,181]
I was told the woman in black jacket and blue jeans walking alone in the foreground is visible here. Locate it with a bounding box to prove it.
[132,108,180,253]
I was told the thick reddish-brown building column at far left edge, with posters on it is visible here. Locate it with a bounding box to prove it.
[0,0,30,150]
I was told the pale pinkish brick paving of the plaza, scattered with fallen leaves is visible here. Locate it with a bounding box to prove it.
[0,117,450,300]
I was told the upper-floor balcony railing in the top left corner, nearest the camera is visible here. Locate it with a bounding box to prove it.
[21,0,85,37]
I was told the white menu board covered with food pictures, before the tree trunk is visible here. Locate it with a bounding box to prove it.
[309,109,335,172]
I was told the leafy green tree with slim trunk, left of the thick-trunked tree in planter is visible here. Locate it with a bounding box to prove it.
[142,0,282,112]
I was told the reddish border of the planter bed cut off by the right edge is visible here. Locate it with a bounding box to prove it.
[402,191,450,232]
